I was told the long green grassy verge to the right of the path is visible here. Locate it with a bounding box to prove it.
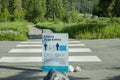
[37,18,120,39]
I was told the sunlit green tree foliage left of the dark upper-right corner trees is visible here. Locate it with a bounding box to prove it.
[0,0,98,23]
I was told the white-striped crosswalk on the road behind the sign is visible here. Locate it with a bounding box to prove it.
[0,40,102,63]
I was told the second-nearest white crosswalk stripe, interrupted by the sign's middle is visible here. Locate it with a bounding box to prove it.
[9,48,91,53]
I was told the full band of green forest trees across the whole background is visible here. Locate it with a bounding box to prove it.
[0,0,120,22]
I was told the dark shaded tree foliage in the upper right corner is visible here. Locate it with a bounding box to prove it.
[93,0,120,17]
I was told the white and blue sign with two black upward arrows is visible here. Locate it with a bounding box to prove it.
[42,33,69,72]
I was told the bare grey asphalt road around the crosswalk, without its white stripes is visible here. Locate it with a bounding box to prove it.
[0,39,120,80]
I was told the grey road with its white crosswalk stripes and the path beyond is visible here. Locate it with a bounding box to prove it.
[0,26,120,80]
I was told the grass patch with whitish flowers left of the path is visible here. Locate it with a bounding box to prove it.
[0,22,29,41]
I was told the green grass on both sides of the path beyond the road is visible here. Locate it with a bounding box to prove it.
[0,17,120,41]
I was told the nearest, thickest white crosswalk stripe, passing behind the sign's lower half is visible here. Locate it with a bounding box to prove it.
[0,56,102,63]
